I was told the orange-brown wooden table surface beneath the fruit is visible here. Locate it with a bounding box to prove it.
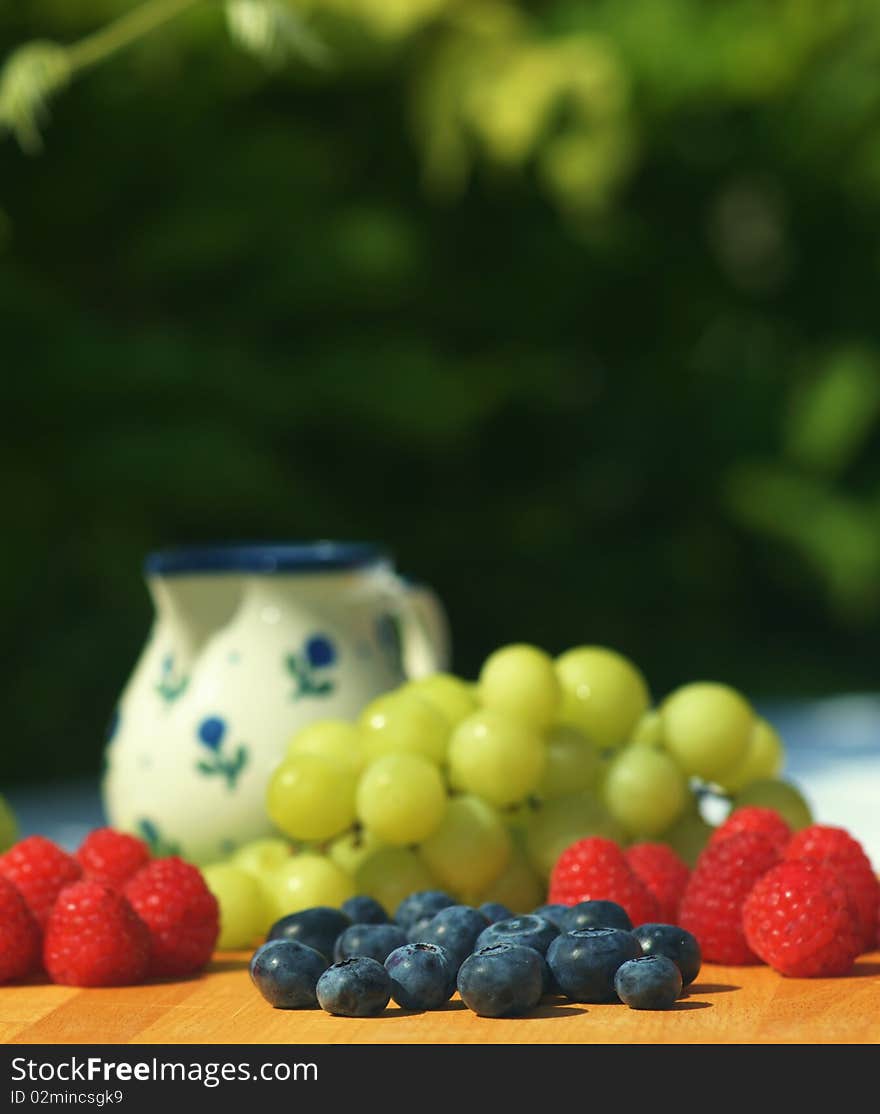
[0,952,880,1045]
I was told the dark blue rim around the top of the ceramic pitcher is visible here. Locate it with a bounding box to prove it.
[144,540,391,576]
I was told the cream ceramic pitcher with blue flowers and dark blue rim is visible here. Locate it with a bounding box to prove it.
[102,541,449,864]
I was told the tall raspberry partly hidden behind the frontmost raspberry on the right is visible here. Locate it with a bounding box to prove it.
[678,831,780,967]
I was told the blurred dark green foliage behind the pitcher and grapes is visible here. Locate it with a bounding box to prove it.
[0,0,880,782]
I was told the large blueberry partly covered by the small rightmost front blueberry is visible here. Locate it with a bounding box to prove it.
[547,928,642,1003]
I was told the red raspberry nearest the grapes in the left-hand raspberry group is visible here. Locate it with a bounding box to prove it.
[124,856,219,978]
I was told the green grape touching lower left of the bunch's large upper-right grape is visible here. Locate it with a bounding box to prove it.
[602,746,691,838]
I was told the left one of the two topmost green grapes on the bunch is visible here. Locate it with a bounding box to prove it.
[478,643,561,731]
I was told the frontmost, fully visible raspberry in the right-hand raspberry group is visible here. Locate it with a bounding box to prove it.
[743,859,861,978]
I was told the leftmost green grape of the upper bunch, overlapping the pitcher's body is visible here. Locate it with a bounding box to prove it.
[266,754,358,841]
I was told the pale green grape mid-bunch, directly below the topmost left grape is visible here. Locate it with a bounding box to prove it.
[448,707,547,808]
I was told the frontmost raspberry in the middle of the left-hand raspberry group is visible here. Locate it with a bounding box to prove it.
[42,881,150,986]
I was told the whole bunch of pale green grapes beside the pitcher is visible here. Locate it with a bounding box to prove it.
[199,643,812,947]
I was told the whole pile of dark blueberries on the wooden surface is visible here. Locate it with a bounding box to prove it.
[250,890,702,1017]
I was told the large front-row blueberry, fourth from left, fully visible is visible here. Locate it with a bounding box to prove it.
[457,944,544,1017]
